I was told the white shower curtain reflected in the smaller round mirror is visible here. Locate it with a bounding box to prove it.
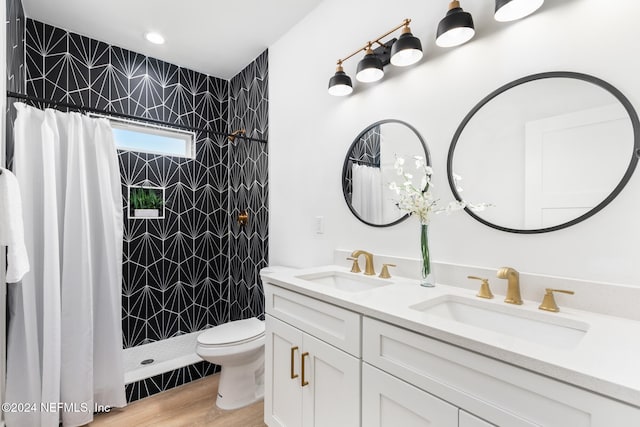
[351,163,382,224]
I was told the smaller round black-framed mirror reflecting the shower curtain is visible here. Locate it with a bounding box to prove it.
[342,119,431,227]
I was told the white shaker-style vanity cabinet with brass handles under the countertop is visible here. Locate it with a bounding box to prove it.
[265,282,640,427]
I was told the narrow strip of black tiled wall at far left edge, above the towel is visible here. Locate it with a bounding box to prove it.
[0,0,25,169]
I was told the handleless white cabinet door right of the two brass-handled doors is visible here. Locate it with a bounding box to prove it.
[362,363,458,427]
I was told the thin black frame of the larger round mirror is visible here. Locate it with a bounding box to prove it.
[447,71,640,234]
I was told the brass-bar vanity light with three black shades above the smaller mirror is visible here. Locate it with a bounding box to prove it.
[329,19,422,96]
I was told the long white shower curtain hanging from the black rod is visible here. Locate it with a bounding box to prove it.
[5,103,126,427]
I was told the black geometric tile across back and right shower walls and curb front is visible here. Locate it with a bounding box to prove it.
[25,19,268,398]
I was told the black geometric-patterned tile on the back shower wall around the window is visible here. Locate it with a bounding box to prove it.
[26,20,230,348]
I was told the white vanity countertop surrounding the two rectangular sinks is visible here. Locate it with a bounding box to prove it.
[261,265,640,407]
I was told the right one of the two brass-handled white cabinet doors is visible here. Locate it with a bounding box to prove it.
[297,334,361,427]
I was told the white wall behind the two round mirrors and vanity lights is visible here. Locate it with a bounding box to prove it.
[269,0,640,286]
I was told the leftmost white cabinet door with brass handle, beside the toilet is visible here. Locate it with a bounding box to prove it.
[264,315,302,427]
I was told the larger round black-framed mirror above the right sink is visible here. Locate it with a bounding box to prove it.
[447,72,640,233]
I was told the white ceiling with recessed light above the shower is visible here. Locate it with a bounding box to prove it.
[22,0,322,80]
